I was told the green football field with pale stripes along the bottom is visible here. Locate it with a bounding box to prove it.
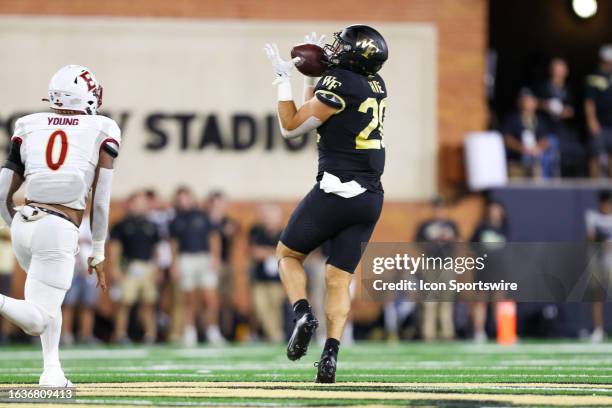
[0,342,612,407]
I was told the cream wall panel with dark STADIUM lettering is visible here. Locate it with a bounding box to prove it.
[0,16,437,201]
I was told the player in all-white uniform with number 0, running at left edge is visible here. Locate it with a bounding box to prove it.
[0,65,121,387]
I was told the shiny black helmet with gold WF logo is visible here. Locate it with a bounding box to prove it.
[325,24,389,76]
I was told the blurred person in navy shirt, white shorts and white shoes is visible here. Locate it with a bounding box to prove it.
[170,187,225,347]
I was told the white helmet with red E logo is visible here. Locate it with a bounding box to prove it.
[49,65,102,115]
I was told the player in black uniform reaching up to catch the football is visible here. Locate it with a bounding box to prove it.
[266,25,388,383]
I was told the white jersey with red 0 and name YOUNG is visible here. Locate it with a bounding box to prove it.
[11,112,121,210]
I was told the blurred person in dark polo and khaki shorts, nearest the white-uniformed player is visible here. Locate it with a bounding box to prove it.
[110,192,160,344]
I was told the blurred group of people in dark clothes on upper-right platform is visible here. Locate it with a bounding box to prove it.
[494,45,612,178]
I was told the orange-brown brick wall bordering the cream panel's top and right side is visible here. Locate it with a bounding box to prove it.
[0,0,488,184]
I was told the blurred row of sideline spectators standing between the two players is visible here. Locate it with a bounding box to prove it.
[0,187,324,347]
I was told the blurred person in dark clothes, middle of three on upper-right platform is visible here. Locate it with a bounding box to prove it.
[536,58,587,177]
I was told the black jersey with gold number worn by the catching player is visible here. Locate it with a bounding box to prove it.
[315,68,387,193]
